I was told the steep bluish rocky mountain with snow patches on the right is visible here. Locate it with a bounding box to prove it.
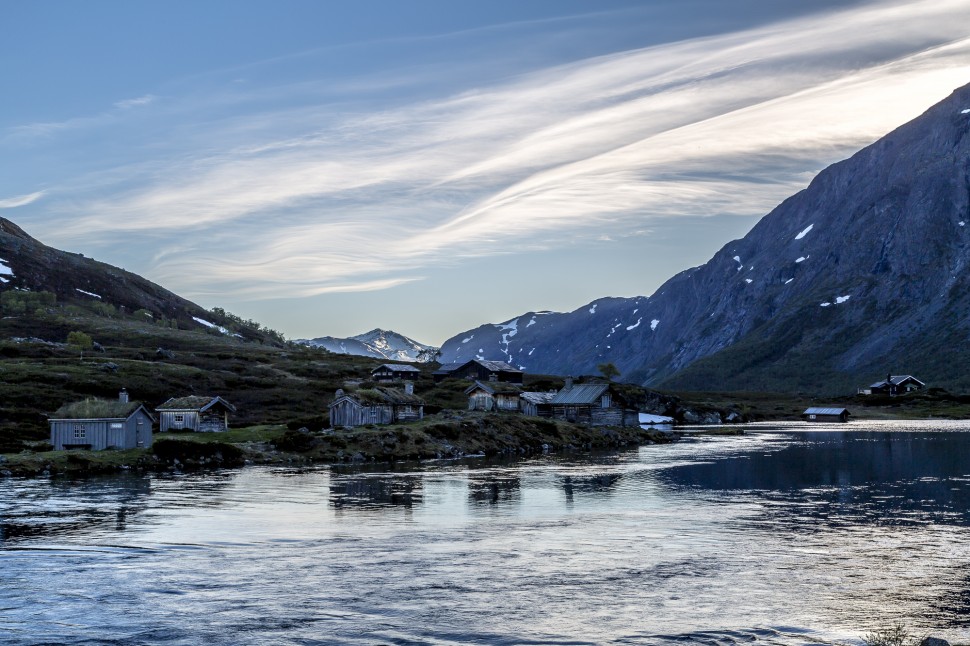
[441,81,970,393]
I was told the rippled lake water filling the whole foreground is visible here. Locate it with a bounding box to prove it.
[0,423,970,645]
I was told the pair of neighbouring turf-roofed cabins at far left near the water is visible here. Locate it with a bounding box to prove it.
[49,389,236,451]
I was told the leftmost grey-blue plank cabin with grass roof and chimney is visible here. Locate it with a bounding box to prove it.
[49,390,155,451]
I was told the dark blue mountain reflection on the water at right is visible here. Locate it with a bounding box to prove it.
[658,431,970,525]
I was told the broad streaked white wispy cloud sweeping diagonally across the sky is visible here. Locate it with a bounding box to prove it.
[26,0,970,298]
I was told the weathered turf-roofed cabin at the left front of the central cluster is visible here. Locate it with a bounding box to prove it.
[329,383,424,428]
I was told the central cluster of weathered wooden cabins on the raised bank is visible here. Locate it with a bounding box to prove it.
[330,359,639,428]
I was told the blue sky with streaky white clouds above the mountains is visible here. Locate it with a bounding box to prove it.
[0,0,970,345]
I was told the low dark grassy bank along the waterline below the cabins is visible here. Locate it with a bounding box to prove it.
[0,411,672,476]
